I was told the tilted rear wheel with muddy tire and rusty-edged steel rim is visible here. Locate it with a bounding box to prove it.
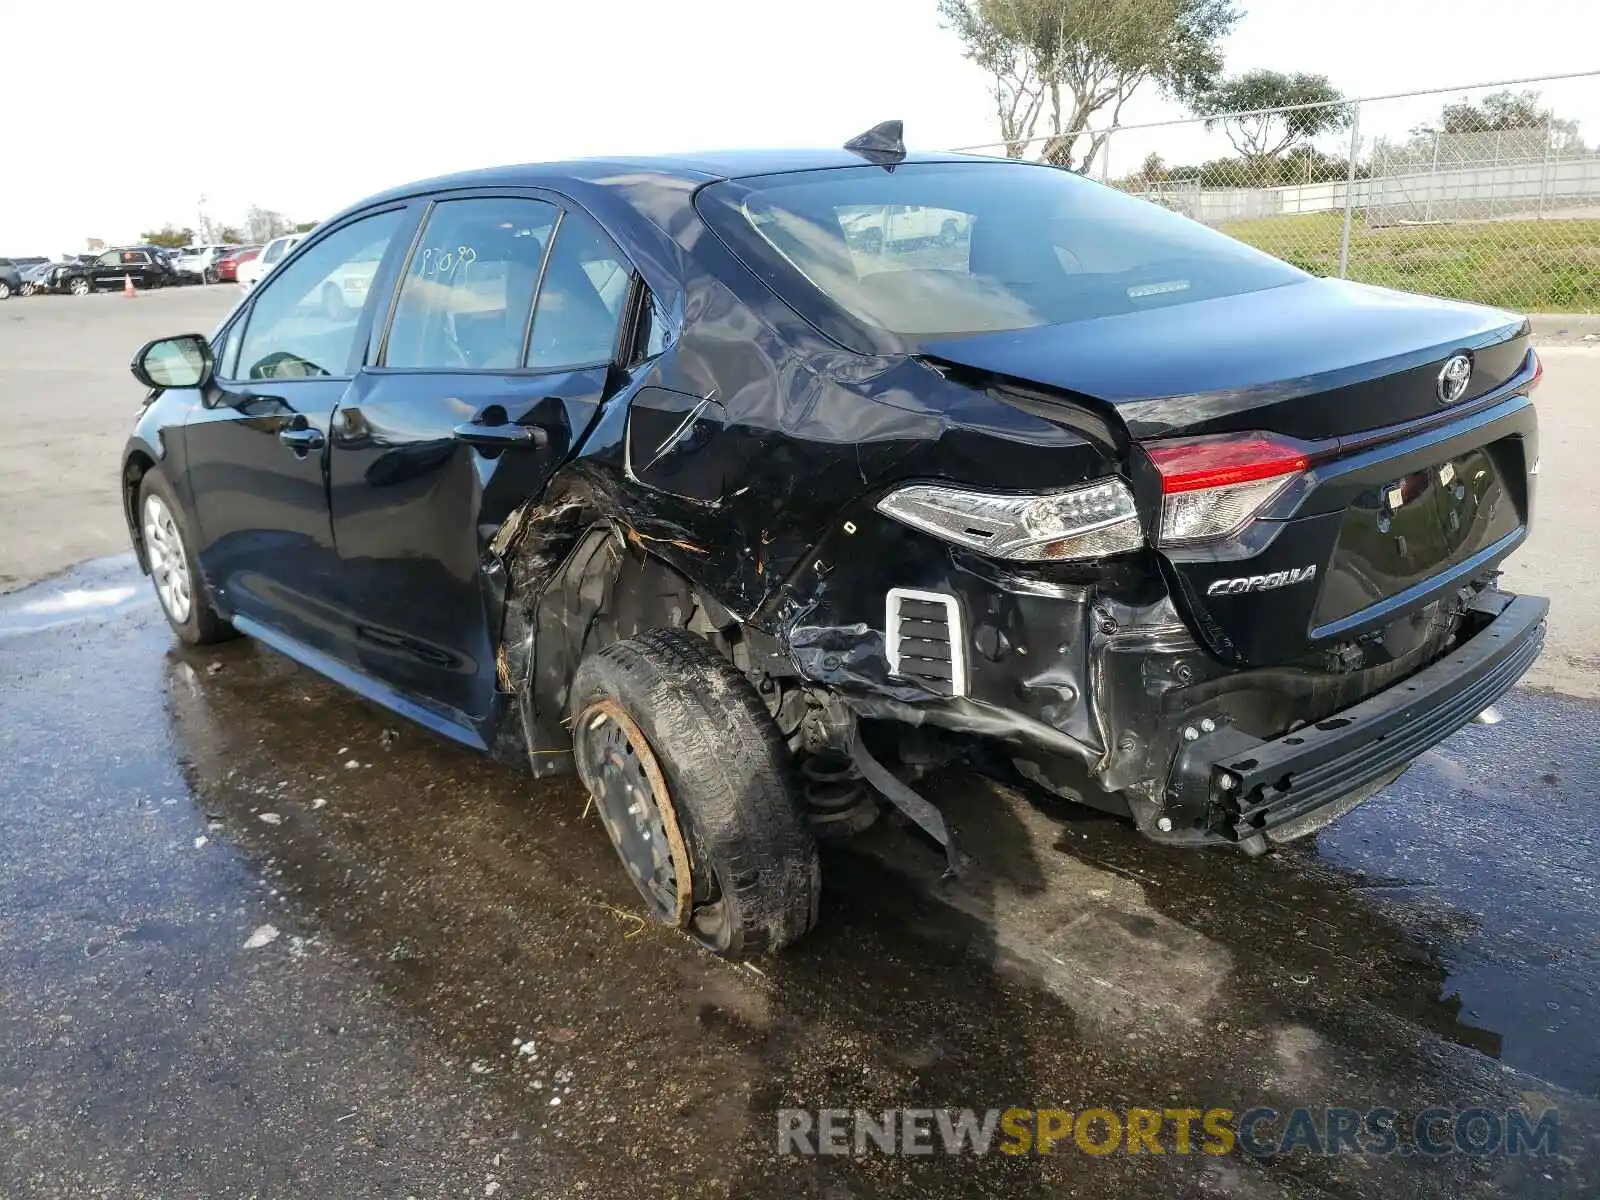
[571,629,821,960]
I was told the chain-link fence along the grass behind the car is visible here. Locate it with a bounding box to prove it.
[953,72,1600,312]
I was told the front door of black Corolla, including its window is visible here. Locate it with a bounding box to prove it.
[184,205,414,666]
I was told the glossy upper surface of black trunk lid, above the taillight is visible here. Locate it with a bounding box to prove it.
[920,278,1526,440]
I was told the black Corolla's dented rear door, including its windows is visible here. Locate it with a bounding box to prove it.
[331,194,630,741]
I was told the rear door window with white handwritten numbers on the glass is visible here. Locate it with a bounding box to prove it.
[384,197,558,371]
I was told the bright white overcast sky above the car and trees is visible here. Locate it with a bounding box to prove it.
[0,0,1600,254]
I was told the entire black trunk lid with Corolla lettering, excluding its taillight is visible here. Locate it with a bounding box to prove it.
[922,280,1538,669]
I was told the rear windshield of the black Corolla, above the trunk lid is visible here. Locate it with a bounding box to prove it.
[702,163,1306,339]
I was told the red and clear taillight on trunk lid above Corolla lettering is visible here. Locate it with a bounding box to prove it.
[1144,434,1310,546]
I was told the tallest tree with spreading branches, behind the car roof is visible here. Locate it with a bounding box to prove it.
[939,0,1240,171]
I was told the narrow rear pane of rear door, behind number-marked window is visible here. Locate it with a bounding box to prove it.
[526,211,629,370]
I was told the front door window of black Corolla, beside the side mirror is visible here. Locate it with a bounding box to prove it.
[238,210,402,379]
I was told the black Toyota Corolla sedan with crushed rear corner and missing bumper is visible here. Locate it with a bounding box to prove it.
[122,126,1547,957]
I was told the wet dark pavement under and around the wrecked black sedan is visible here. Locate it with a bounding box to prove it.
[0,557,1600,1200]
